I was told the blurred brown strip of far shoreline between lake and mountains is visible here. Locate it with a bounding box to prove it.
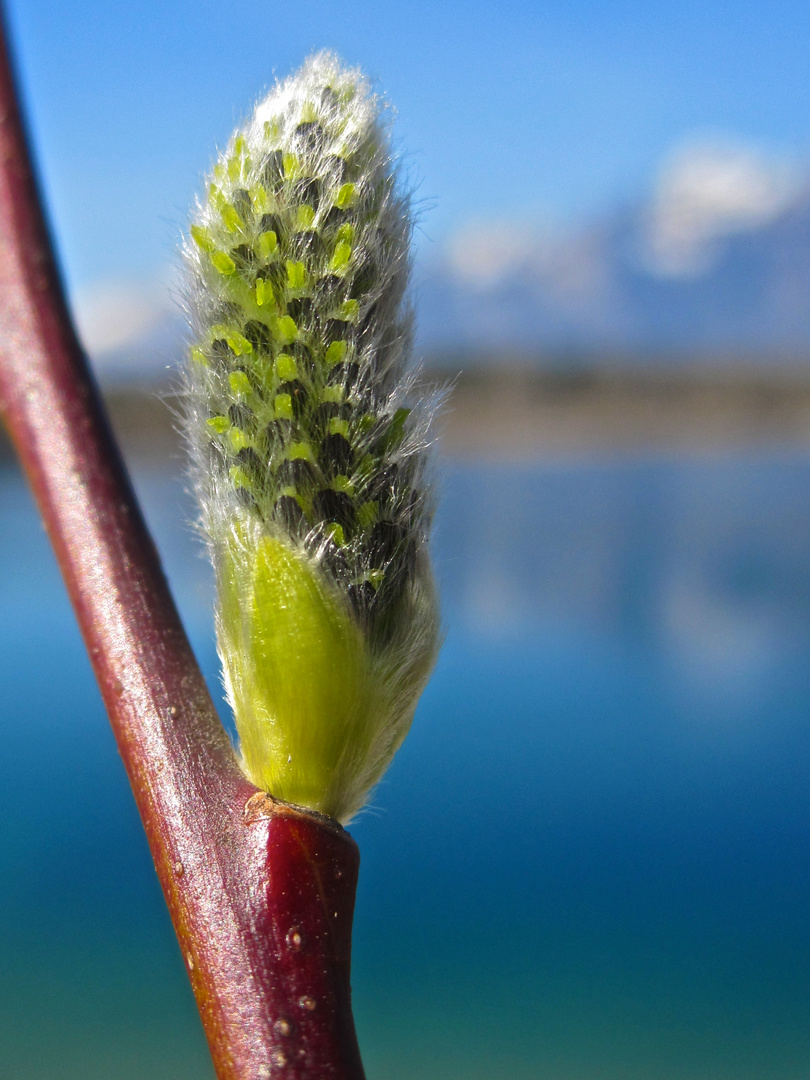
[0,364,810,461]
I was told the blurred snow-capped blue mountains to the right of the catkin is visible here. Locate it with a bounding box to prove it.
[418,141,810,364]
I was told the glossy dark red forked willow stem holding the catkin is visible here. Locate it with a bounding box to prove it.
[0,10,363,1080]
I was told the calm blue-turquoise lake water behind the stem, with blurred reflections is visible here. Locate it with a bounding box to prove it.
[0,453,810,1080]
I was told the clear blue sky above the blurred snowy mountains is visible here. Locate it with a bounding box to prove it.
[8,0,810,298]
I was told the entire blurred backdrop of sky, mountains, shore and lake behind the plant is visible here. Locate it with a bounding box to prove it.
[0,0,810,1080]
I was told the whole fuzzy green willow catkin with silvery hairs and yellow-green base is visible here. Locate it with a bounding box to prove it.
[186,54,438,821]
